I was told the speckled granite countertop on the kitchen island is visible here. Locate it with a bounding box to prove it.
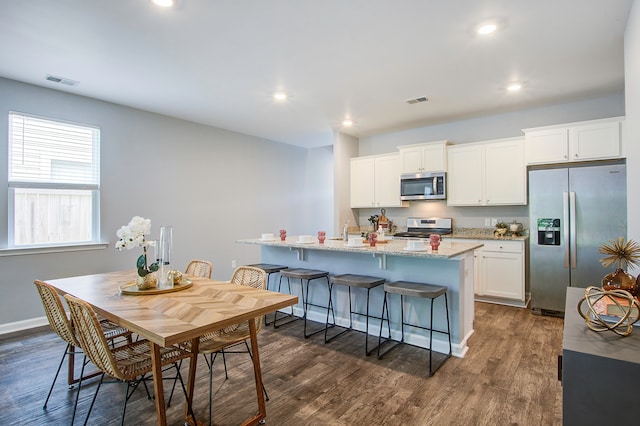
[236,235,482,259]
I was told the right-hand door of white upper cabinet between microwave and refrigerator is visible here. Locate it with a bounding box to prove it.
[484,140,527,205]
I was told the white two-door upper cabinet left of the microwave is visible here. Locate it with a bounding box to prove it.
[351,153,408,208]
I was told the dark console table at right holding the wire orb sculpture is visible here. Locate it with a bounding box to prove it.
[561,288,640,426]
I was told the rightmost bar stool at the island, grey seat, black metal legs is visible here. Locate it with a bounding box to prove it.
[378,281,451,376]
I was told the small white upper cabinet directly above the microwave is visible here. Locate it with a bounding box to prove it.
[398,141,449,173]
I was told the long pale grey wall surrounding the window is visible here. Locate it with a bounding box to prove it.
[0,79,333,333]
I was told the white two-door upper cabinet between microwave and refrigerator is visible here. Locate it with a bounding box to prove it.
[447,138,527,206]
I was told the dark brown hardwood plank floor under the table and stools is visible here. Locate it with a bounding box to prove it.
[0,303,563,425]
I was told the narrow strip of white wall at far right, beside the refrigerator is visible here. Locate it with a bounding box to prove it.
[624,0,640,275]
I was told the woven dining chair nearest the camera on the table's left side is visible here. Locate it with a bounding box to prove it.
[64,294,197,425]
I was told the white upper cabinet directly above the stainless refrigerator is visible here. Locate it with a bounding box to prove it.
[523,117,625,164]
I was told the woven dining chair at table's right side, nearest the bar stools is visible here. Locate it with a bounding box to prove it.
[199,266,269,425]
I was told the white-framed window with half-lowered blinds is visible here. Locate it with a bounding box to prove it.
[8,112,100,247]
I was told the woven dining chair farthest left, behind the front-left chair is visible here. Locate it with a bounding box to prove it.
[34,280,131,410]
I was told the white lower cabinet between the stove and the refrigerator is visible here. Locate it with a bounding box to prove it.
[454,239,529,307]
